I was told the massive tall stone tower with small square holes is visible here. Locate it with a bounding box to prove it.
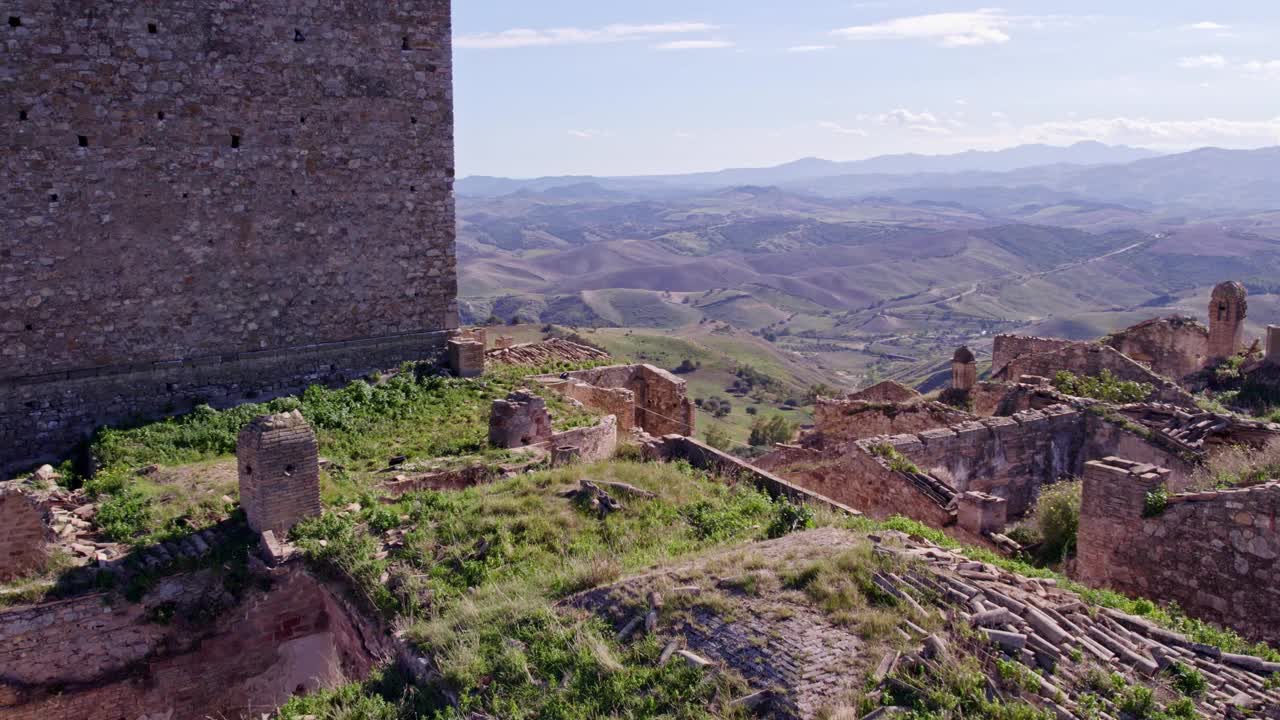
[0,0,457,470]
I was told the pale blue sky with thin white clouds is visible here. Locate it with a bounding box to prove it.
[453,0,1280,177]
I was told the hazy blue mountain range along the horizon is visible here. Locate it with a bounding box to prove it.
[457,142,1280,210]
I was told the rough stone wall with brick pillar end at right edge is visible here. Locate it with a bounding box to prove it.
[1076,459,1280,643]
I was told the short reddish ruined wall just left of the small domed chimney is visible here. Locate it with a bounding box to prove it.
[813,397,975,442]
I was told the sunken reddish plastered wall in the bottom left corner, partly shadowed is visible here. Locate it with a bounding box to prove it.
[0,565,392,720]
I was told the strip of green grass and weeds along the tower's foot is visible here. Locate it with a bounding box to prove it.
[64,365,595,544]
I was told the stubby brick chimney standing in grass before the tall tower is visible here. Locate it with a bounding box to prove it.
[236,410,320,538]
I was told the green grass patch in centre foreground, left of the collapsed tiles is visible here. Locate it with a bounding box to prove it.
[284,461,812,720]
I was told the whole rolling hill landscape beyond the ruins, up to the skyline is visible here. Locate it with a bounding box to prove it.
[458,146,1280,412]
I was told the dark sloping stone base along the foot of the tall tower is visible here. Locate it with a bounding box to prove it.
[0,331,447,477]
